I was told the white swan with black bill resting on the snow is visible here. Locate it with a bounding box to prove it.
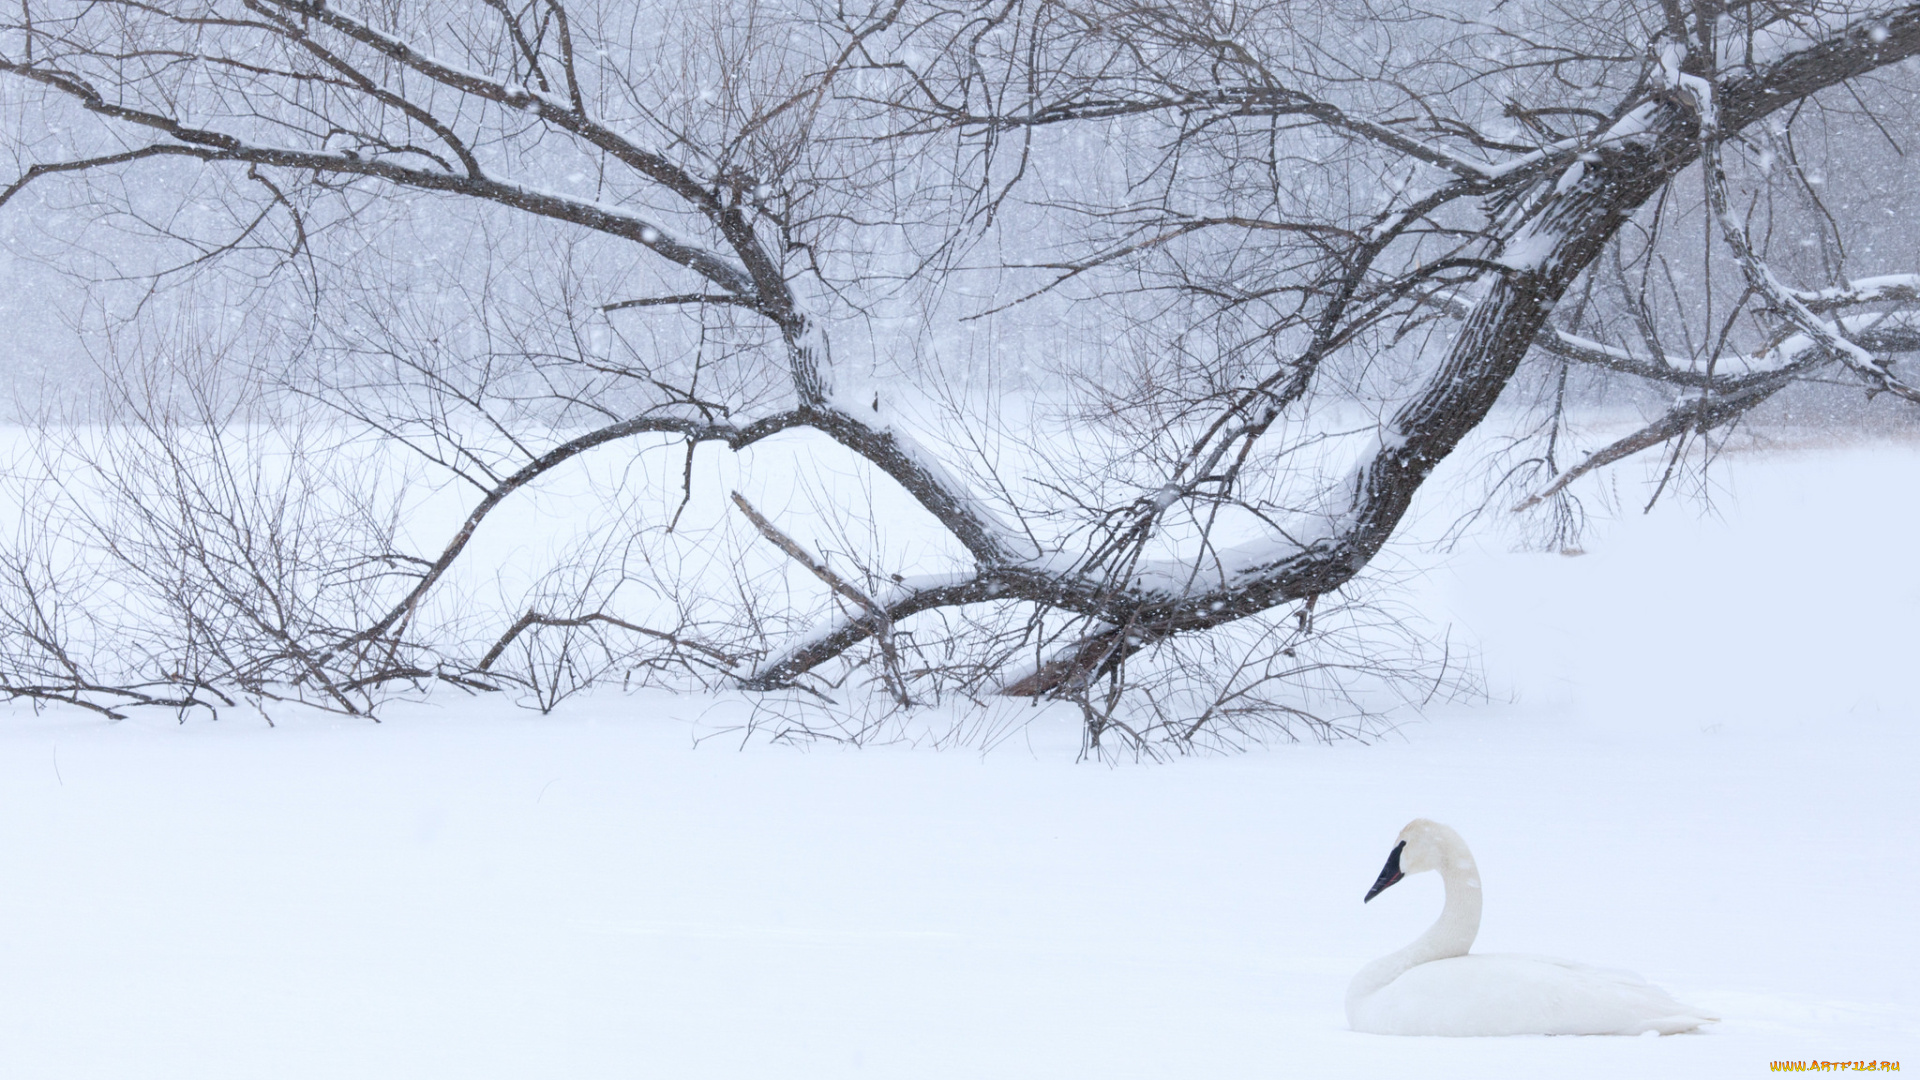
[1346,819,1718,1036]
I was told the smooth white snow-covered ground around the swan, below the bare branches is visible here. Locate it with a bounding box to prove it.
[0,444,1920,1080]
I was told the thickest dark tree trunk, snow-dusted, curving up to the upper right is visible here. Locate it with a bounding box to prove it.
[747,4,1920,696]
